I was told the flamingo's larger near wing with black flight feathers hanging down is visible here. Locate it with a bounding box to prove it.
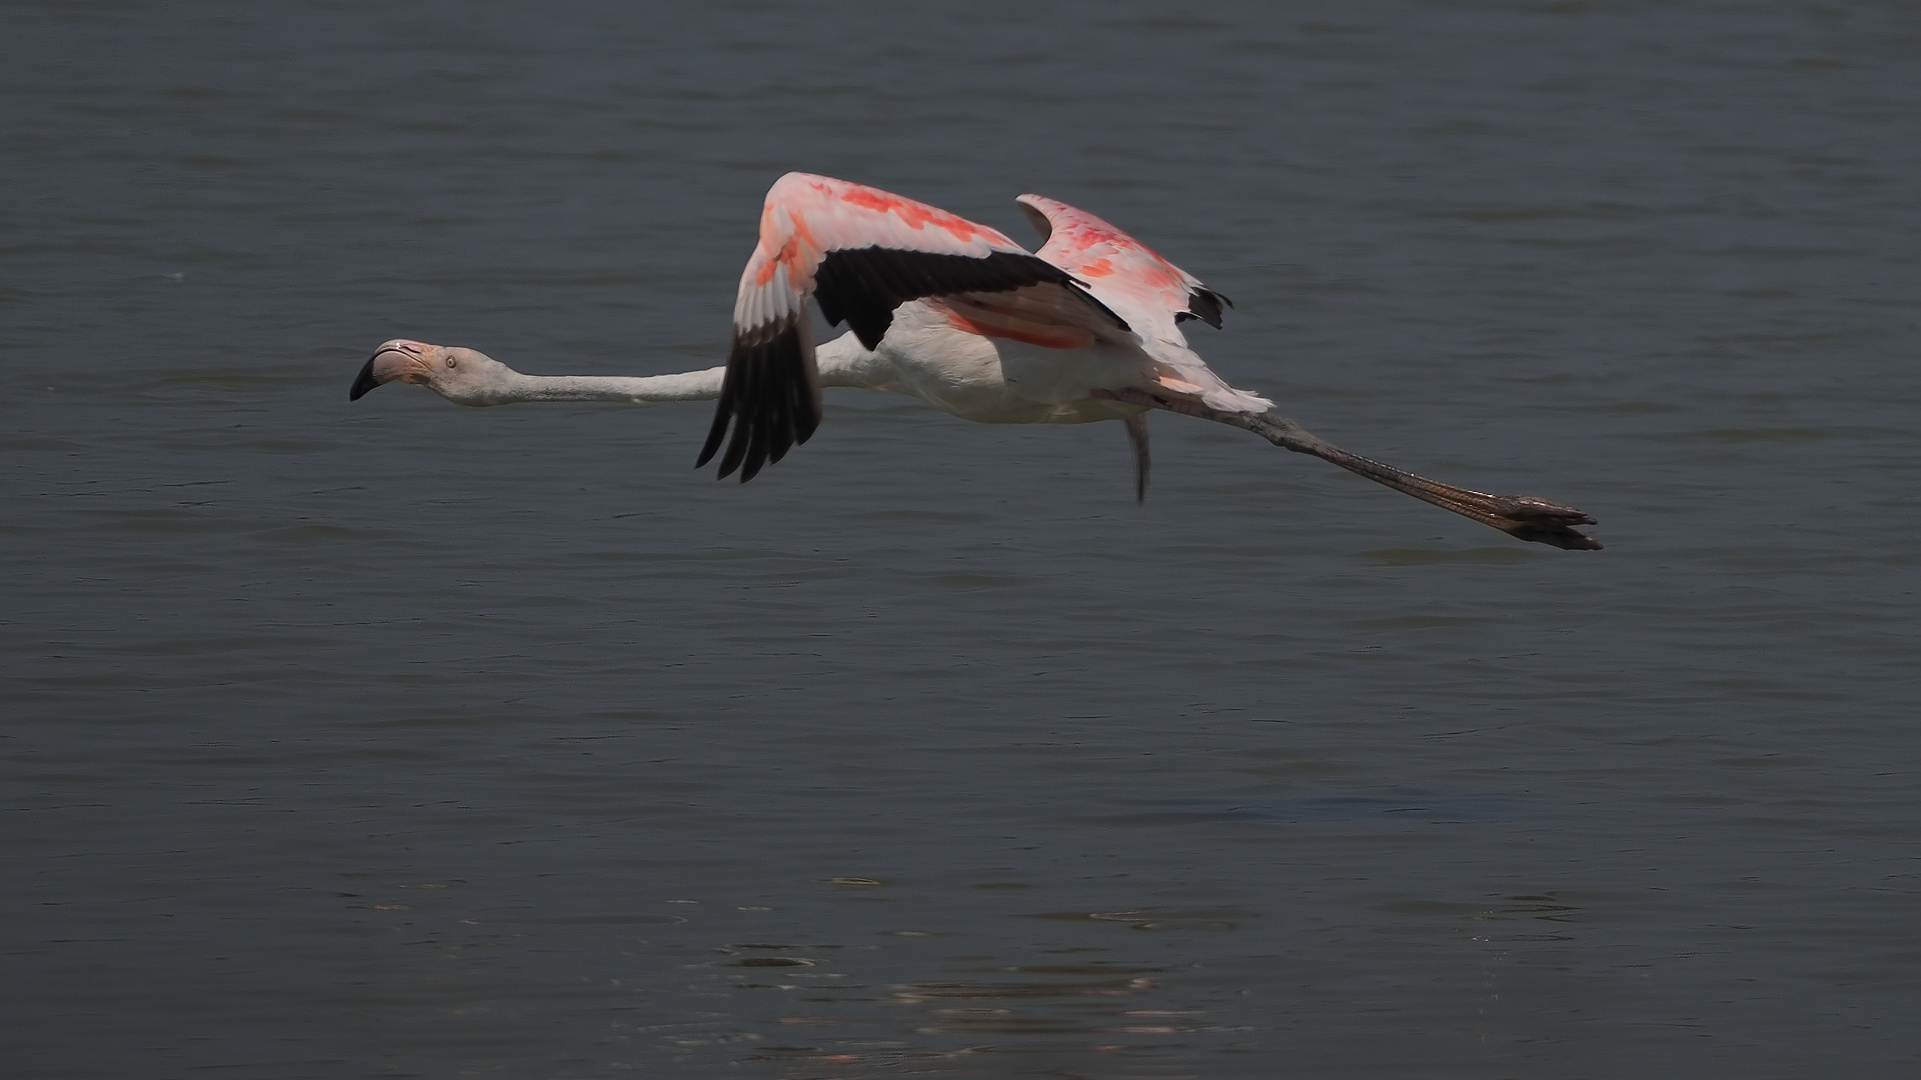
[695,173,1126,482]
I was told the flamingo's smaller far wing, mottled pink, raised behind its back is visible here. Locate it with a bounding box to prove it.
[1014,194,1233,331]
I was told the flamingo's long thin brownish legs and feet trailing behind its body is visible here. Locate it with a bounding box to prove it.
[1095,388,1600,552]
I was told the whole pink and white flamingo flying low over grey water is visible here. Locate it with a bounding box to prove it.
[348,173,1600,550]
